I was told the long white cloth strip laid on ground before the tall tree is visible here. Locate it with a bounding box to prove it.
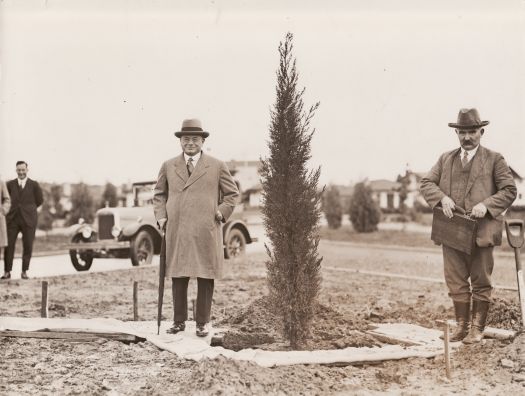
[0,317,460,367]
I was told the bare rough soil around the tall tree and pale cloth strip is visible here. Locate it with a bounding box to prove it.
[0,241,525,395]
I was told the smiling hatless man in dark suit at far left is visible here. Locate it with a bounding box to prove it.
[1,161,44,279]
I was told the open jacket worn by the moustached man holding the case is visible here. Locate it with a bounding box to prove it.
[420,146,517,247]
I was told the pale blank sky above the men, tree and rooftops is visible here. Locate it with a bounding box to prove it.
[0,0,525,184]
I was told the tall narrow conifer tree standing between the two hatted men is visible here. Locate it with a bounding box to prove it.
[261,33,322,348]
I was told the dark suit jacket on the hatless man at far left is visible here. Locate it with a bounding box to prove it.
[6,178,44,228]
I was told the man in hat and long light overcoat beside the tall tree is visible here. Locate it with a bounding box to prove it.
[153,119,239,337]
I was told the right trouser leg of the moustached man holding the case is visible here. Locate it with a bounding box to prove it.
[470,247,494,302]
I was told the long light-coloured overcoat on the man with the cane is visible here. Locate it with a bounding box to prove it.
[153,153,239,279]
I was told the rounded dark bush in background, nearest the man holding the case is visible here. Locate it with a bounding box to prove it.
[349,183,381,232]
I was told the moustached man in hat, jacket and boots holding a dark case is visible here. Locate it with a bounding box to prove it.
[421,109,516,344]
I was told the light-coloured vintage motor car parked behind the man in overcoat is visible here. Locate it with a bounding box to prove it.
[68,181,257,271]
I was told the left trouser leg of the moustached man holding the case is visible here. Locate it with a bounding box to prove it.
[443,245,471,303]
